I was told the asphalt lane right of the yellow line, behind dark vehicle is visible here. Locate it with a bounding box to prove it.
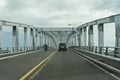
[33,50,117,80]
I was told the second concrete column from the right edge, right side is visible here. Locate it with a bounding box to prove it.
[98,24,104,47]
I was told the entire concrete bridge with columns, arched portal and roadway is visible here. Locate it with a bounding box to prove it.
[0,14,120,80]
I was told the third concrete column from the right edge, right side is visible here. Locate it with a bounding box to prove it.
[88,25,94,46]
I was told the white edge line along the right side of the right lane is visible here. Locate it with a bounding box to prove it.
[75,51,120,80]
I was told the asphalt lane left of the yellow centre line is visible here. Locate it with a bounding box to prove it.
[0,51,53,80]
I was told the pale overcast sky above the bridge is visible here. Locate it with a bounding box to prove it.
[0,0,120,26]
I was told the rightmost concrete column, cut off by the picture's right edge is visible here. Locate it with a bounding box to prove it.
[115,15,120,48]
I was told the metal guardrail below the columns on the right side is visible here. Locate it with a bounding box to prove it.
[79,46,120,57]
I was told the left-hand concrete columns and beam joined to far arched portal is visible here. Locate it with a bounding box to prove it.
[0,20,77,52]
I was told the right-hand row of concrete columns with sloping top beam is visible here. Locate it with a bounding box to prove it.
[77,14,120,47]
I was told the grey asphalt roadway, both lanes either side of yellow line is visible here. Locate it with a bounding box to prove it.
[0,49,118,80]
